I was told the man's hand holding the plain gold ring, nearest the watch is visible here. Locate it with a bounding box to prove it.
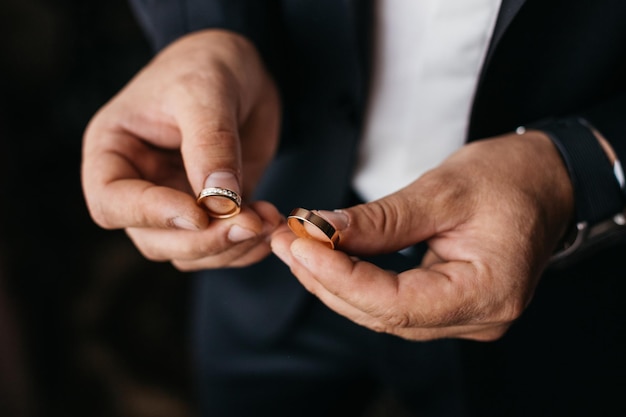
[272,131,573,340]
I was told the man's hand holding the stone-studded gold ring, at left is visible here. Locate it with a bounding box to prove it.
[82,30,281,270]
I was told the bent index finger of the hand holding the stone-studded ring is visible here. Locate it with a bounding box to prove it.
[81,125,208,230]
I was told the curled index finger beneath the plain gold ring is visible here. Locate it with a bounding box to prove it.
[284,234,478,333]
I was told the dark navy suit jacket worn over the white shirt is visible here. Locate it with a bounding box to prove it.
[127,0,626,416]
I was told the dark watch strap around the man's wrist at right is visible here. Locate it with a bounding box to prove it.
[527,117,624,225]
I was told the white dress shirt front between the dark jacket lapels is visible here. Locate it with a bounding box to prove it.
[354,0,500,200]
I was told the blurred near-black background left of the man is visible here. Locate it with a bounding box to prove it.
[0,0,194,417]
